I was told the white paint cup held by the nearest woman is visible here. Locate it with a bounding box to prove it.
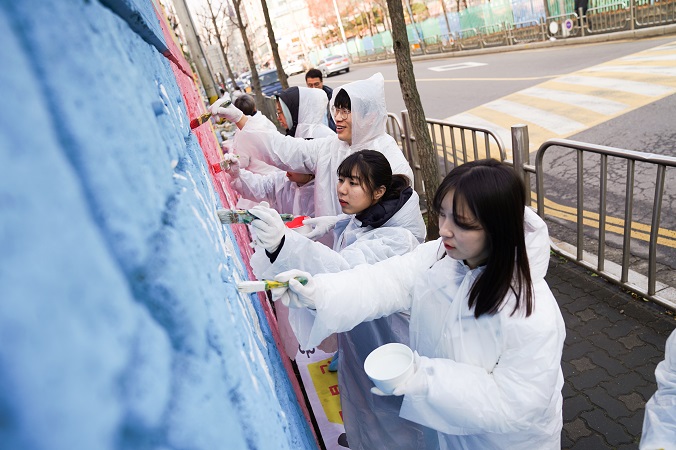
[364,343,414,394]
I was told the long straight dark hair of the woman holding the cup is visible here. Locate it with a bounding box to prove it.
[433,159,533,318]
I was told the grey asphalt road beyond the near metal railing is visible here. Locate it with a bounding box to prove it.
[290,35,676,286]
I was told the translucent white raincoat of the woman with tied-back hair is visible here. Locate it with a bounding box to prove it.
[251,187,436,450]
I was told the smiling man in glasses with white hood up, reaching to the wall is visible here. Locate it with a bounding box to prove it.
[209,73,414,243]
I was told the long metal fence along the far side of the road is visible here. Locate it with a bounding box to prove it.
[350,0,676,63]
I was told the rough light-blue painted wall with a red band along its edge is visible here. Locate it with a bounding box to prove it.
[0,0,315,450]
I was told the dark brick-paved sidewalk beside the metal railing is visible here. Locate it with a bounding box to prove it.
[546,255,676,450]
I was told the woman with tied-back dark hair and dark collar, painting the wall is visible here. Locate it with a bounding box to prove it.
[250,150,434,450]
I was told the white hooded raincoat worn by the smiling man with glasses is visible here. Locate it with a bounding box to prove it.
[235,73,413,220]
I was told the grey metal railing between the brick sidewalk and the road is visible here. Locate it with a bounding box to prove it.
[388,111,676,310]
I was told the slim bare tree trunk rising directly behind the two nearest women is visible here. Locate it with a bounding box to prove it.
[387,0,439,240]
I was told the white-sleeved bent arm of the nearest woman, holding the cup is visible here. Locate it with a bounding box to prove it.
[400,281,565,435]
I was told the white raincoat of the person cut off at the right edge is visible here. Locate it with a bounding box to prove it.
[639,330,676,450]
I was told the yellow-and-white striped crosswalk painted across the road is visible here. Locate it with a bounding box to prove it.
[445,41,676,159]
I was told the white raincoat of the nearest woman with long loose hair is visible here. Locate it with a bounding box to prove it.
[293,208,565,450]
